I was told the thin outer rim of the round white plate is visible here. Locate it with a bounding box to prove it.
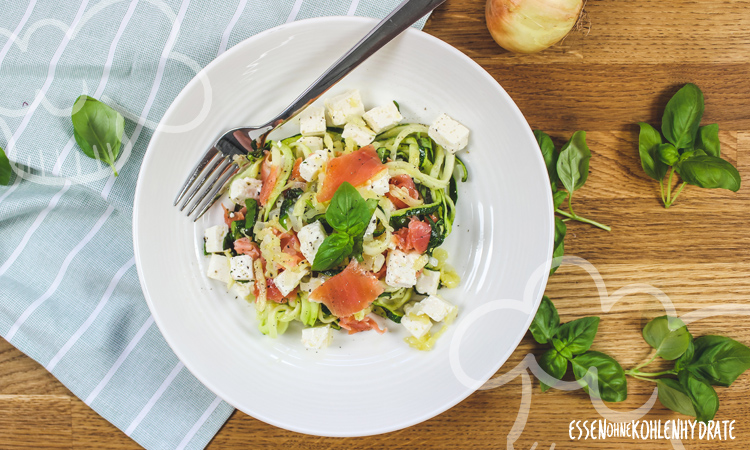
[132,16,554,437]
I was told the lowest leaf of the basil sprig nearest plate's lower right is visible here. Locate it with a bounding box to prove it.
[571,351,628,402]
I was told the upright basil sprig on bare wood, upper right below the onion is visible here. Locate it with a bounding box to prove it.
[638,83,741,208]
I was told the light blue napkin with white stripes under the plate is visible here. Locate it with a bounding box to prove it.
[0,0,432,449]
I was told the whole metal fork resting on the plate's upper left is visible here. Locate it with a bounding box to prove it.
[174,0,445,221]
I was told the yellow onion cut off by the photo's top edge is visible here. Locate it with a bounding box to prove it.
[485,0,583,53]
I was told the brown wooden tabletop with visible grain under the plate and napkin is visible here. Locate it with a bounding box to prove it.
[0,0,750,450]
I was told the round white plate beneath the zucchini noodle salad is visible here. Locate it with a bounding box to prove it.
[133,17,553,436]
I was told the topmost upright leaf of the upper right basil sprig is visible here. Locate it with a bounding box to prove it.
[661,83,704,149]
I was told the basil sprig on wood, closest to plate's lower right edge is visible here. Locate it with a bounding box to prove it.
[529,296,628,402]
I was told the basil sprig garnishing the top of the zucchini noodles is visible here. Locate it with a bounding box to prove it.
[312,182,377,271]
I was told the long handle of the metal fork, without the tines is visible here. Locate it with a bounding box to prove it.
[266,0,446,128]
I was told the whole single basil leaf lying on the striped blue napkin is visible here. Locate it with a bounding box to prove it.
[70,95,125,176]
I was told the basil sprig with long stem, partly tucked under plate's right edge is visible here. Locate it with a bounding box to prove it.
[534,130,612,236]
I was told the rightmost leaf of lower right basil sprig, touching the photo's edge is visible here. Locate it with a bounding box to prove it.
[680,335,750,386]
